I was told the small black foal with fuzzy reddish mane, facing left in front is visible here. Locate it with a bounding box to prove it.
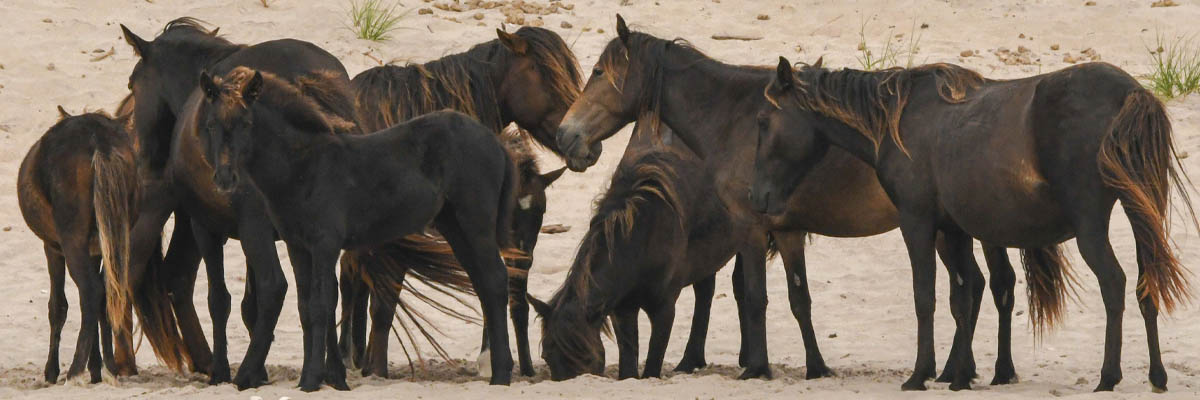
[198,67,516,392]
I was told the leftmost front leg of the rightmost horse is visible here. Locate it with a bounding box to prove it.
[900,214,937,390]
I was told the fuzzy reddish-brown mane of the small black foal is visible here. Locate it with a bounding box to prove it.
[217,66,360,133]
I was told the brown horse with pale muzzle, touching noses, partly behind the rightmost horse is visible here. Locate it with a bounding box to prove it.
[557,16,1036,384]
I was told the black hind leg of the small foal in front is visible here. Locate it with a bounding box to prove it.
[437,207,512,386]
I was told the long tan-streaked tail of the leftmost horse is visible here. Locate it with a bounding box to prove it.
[91,133,138,360]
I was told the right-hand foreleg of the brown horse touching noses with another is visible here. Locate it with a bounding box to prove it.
[773,232,833,380]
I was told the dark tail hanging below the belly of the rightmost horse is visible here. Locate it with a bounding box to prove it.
[1021,245,1076,335]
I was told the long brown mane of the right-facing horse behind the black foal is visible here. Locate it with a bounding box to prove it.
[353,26,582,133]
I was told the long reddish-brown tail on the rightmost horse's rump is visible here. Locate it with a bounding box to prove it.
[1097,88,1196,314]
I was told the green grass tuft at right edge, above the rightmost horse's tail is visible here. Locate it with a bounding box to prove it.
[1146,32,1200,100]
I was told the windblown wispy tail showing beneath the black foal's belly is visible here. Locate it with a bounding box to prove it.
[342,234,480,359]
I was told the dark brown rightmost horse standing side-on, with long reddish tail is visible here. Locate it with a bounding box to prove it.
[750,58,1195,392]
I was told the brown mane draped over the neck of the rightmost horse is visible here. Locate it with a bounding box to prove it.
[768,64,985,154]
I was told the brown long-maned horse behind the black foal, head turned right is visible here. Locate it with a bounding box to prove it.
[340,26,581,377]
